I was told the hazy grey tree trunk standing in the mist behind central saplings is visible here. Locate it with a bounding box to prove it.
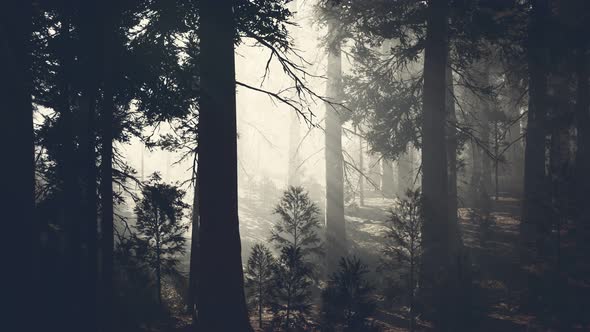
[325,15,346,271]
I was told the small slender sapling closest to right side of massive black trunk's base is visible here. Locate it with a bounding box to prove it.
[245,243,276,328]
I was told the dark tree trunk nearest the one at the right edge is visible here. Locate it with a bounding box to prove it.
[520,0,549,252]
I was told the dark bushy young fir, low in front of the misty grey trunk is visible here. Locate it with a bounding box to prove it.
[322,257,375,331]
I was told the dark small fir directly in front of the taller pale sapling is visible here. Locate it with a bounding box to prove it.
[271,245,312,331]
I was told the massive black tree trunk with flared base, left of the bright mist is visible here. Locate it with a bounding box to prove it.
[198,0,252,332]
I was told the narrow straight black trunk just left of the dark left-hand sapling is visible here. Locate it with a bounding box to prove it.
[100,1,117,331]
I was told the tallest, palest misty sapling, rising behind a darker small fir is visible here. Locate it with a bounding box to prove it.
[270,186,323,259]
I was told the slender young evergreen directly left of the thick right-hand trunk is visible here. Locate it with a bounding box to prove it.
[380,190,424,331]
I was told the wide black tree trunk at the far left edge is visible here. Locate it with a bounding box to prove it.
[0,0,37,331]
